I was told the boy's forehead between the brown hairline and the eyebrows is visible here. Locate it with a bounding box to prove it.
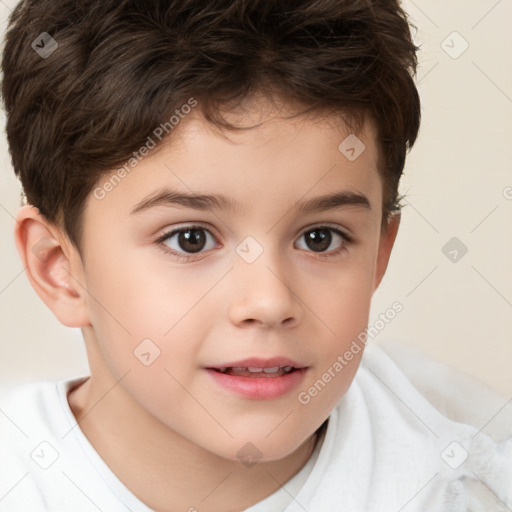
[87,103,381,222]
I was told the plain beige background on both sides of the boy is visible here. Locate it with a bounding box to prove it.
[0,0,512,397]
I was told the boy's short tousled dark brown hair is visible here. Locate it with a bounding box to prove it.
[2,0,420,251]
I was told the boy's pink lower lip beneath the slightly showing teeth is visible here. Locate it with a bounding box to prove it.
[206,368,307,400]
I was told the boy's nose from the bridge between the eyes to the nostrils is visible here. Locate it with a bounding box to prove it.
[230,236,301,325]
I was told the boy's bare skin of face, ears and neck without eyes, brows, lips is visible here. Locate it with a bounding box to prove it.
[15,97,400,512]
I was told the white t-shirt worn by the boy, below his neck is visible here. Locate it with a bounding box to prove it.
[0,344,512,512]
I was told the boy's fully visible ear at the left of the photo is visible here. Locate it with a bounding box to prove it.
[14,205,90,327]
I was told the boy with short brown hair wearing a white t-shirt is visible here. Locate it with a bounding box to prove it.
[0,0,512,512]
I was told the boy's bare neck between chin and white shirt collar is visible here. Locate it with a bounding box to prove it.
[68,377,317,512]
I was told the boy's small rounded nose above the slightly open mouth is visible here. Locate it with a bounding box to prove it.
[229,249,304,328]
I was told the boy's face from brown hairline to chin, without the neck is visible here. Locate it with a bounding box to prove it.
[54,103,394,460]
